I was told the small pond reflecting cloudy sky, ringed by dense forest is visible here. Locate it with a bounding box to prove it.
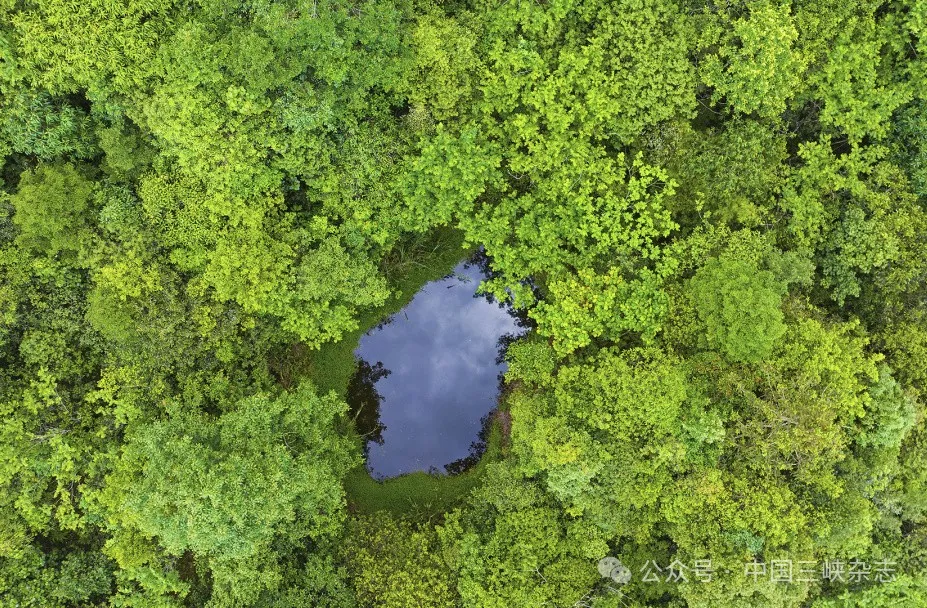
[348,254,529,479]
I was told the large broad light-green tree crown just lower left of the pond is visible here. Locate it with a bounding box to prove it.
[99,384,356,601]
